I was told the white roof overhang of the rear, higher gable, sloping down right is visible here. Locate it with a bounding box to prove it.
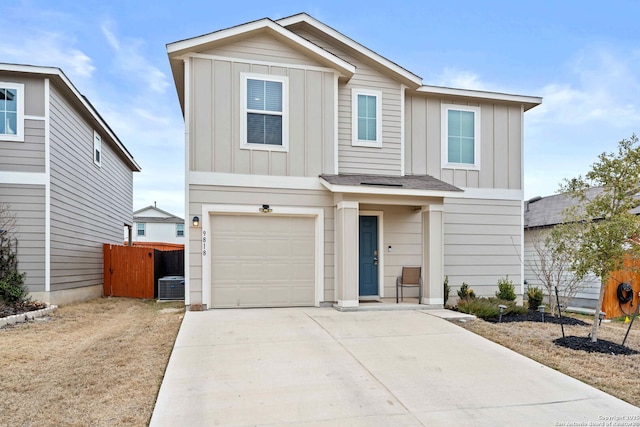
[276,13,422,89]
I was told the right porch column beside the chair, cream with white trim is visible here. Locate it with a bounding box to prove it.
[422,204,444,308]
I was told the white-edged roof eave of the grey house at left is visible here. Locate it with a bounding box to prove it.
[0,63,141,172]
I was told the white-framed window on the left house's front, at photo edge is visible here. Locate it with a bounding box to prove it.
[0,82,24,141]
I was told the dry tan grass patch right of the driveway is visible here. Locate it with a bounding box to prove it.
[460,315,640,406]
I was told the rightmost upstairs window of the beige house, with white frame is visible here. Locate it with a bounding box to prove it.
[442,105,480,169]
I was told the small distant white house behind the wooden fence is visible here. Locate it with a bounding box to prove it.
[125,206,185,244]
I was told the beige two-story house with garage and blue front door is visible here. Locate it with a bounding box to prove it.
[167,14,542,308]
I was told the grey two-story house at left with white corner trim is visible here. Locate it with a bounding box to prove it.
[0,64,140,304]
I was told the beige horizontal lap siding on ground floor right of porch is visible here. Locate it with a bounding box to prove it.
[444,198,522,297]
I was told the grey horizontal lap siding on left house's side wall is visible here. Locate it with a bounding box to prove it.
[50,86,133,291]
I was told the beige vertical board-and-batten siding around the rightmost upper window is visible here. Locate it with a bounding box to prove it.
[405,93,523,189]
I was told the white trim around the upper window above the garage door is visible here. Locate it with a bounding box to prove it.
[240,73,289,152]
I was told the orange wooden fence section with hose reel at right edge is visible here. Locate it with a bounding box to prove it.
[602,257,640,319]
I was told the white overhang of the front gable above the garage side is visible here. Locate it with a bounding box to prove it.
[167,18,356,111]
